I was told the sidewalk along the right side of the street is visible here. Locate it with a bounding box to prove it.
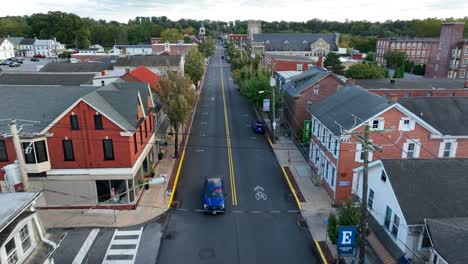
[259,113,336,260]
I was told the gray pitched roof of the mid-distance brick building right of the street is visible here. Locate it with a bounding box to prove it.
[283,67,332,96]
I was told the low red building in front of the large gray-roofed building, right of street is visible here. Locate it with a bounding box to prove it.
[262,54,318,72]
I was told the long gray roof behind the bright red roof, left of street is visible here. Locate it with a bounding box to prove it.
[115,55,181,66]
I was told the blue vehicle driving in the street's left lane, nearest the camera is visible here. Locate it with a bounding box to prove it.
[203,178,226,214]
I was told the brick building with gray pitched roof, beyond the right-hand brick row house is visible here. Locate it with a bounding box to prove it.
[281,67,344,132]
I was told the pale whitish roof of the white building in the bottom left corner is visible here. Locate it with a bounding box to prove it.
[0,192,40,232]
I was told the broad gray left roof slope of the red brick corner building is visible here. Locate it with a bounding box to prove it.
[0,85,99,134]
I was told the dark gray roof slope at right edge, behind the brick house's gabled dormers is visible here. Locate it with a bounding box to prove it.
[398,96,468,136]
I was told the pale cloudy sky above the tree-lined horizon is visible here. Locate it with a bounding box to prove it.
[0,0,468,22]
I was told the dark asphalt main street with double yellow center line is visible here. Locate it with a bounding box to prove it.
[158,47,320,264]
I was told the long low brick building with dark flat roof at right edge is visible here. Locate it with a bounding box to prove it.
[348,78,468,98]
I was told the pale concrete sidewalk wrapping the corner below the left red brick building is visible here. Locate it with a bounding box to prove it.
[38,138,176,228]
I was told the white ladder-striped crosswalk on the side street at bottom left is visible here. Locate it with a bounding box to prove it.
[102,227,143,264]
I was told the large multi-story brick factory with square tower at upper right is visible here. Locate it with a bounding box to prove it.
[376,22,468,79]
